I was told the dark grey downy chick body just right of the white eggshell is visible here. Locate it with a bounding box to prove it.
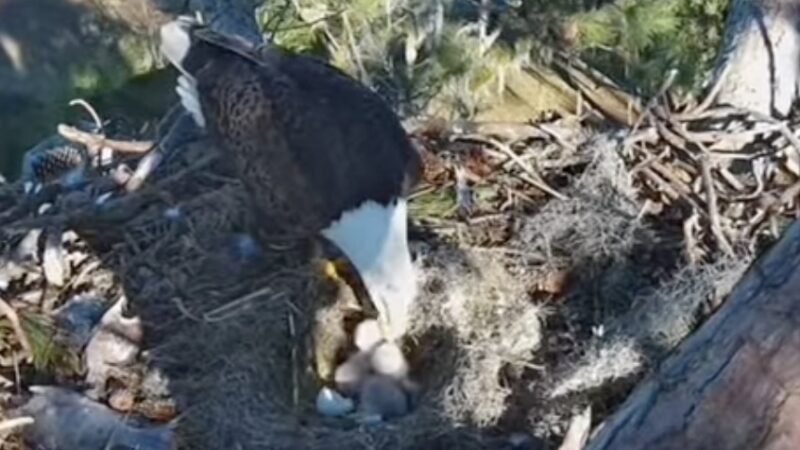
[358,375,409,419]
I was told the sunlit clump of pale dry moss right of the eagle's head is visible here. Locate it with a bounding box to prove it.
[414,246,544,427]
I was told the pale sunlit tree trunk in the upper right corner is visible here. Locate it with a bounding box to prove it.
[712,0,800,117]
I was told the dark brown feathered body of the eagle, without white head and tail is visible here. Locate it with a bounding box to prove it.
[166,21,421,234]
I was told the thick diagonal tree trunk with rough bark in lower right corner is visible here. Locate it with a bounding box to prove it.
[587,222,800,450]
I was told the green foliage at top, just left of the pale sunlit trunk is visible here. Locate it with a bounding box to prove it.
[570,0,728,95]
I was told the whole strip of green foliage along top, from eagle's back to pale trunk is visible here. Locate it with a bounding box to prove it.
[260,0,729,116]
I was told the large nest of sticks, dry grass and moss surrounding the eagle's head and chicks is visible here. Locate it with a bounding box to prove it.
[0,89,800,449]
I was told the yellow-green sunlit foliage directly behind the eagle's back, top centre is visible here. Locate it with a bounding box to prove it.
[260,0,530,115]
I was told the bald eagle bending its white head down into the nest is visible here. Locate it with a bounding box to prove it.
[155,17,421,340]
